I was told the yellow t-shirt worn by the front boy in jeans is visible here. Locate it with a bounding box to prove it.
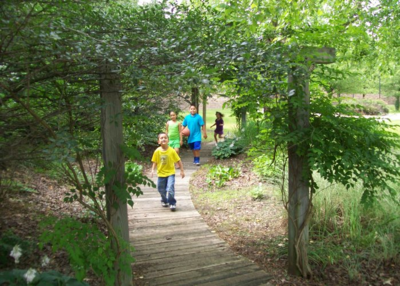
[151,146,181,178]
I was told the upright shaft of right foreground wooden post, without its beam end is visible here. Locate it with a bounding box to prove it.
[288,66,311,277]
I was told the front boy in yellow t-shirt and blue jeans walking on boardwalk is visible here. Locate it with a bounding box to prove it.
[151,132,185,211]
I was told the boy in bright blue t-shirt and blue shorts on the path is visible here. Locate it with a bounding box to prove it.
[182,104,207,166]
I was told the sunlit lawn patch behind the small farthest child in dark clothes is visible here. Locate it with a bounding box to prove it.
[183,108,236,142]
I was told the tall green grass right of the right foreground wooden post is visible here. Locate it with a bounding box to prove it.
[310,172,400,268]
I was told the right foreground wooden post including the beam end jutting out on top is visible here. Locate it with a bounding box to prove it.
[288,47,335,277]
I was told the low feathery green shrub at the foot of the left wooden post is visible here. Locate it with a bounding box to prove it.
[40,218,134,285]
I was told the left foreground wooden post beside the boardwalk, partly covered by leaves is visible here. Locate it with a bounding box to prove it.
[100,63,132,285]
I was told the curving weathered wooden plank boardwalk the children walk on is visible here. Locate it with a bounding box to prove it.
[128,142,271,285]
